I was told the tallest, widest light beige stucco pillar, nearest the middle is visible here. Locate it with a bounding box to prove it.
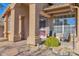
[27,4,36,45]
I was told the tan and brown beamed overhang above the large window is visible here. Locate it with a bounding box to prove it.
[41,4,76,18]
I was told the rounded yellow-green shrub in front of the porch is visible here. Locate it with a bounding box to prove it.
[44,37,60,47]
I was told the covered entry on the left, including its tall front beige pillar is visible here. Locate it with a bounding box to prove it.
[2,3,40,45]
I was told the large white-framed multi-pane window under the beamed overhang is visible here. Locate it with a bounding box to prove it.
[52,18,76,34]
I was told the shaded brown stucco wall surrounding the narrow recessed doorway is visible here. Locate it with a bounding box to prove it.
[14,4,29,40]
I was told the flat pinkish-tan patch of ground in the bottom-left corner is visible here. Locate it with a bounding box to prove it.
[1,48,18,56]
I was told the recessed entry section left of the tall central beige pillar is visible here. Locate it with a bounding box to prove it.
[3,3,29,41]
